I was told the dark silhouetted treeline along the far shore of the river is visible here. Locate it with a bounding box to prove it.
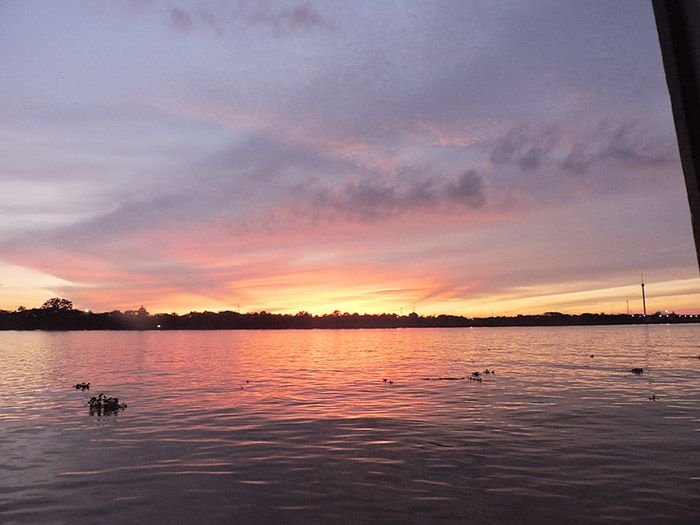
[0,301,700,330]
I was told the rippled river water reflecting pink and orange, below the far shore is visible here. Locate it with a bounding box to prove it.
[0,326,700,523]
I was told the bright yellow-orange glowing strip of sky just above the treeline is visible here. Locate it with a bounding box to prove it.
[6,260,700,317]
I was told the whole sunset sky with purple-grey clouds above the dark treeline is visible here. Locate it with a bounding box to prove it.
[0,0,700,316]
